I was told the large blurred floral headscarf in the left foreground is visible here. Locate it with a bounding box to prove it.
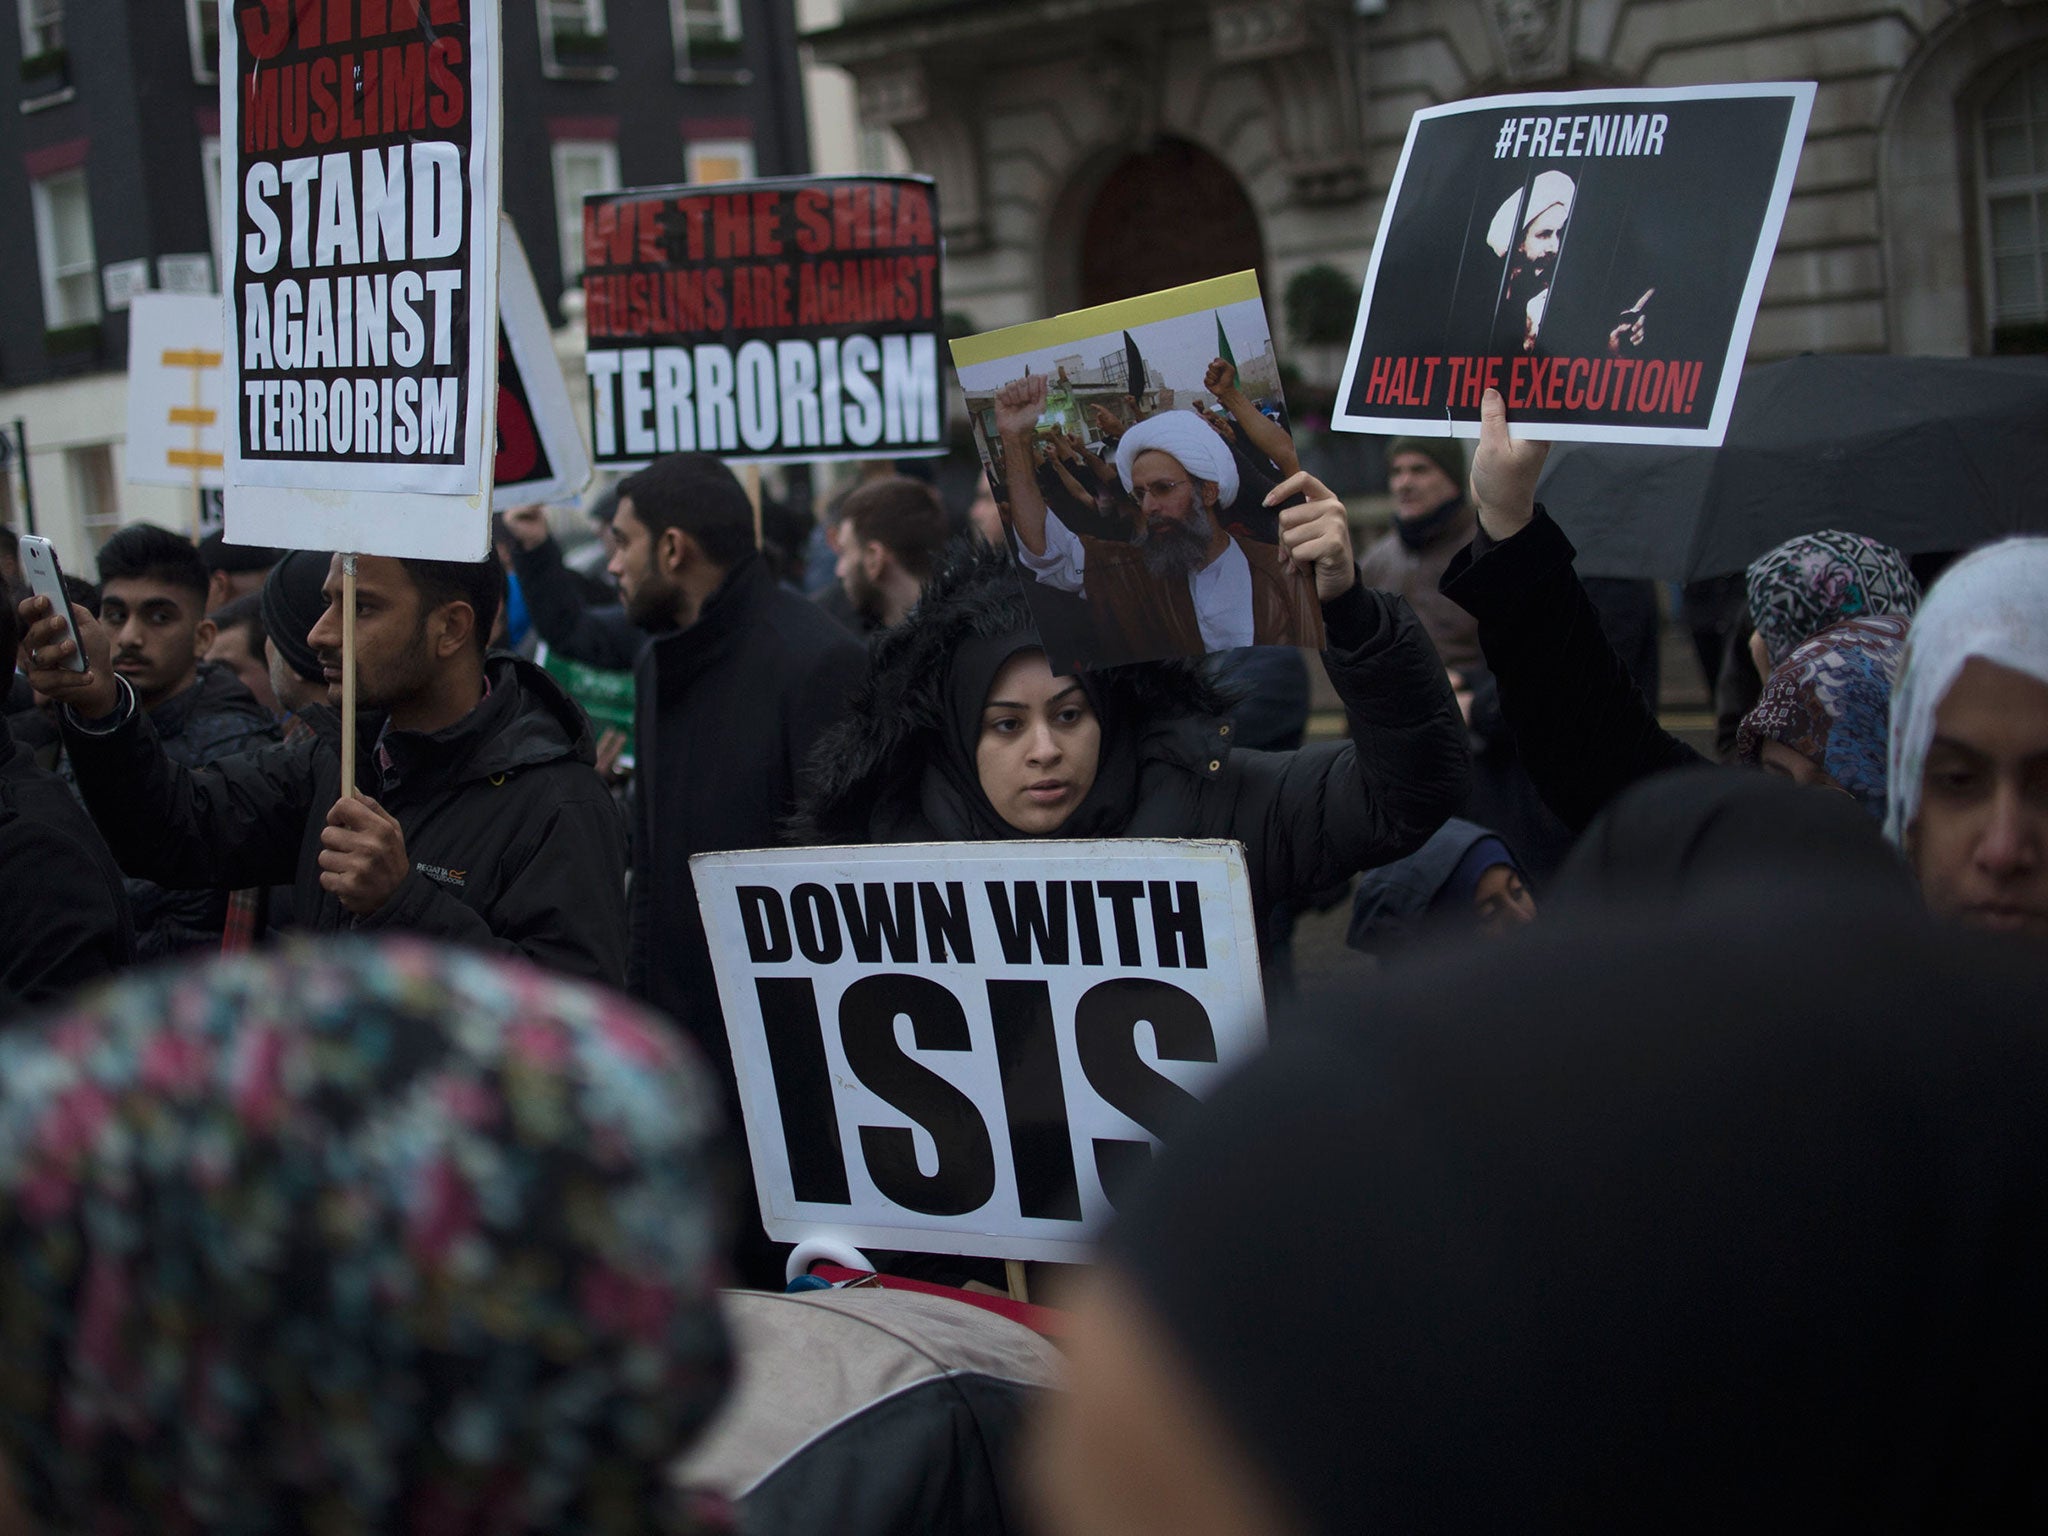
[0,940,729,1536]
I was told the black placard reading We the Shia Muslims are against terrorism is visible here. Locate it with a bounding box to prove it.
[584,176,946,469]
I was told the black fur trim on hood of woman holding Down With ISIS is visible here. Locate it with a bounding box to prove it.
[791,541,1229,844]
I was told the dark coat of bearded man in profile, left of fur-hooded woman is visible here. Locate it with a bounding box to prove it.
[631,555,866,1056]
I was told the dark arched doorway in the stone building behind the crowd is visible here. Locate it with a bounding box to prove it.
[1079,139,1266,307]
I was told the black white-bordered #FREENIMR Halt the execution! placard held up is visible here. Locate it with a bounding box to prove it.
[1335,84,1815,446]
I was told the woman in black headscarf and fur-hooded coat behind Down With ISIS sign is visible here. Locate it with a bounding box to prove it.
[797,507,1466,932]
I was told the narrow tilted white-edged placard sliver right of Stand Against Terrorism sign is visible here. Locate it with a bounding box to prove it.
[492,219,590,512]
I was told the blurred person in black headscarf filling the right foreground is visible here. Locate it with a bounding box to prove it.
[1036,876,2048,1536]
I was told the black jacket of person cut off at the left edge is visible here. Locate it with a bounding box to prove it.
[0,725,135,1018]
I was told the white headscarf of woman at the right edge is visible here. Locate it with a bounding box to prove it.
[1884,537,2048,848]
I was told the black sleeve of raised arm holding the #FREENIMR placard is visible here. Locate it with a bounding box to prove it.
[1444,506,1706,834]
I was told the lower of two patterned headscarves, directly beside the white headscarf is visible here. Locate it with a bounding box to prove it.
[1735,614,1907,821]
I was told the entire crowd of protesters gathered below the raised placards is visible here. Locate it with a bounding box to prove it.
[0,377,2048,1536]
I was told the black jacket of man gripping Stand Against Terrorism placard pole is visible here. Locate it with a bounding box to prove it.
[63,653,627,985]
